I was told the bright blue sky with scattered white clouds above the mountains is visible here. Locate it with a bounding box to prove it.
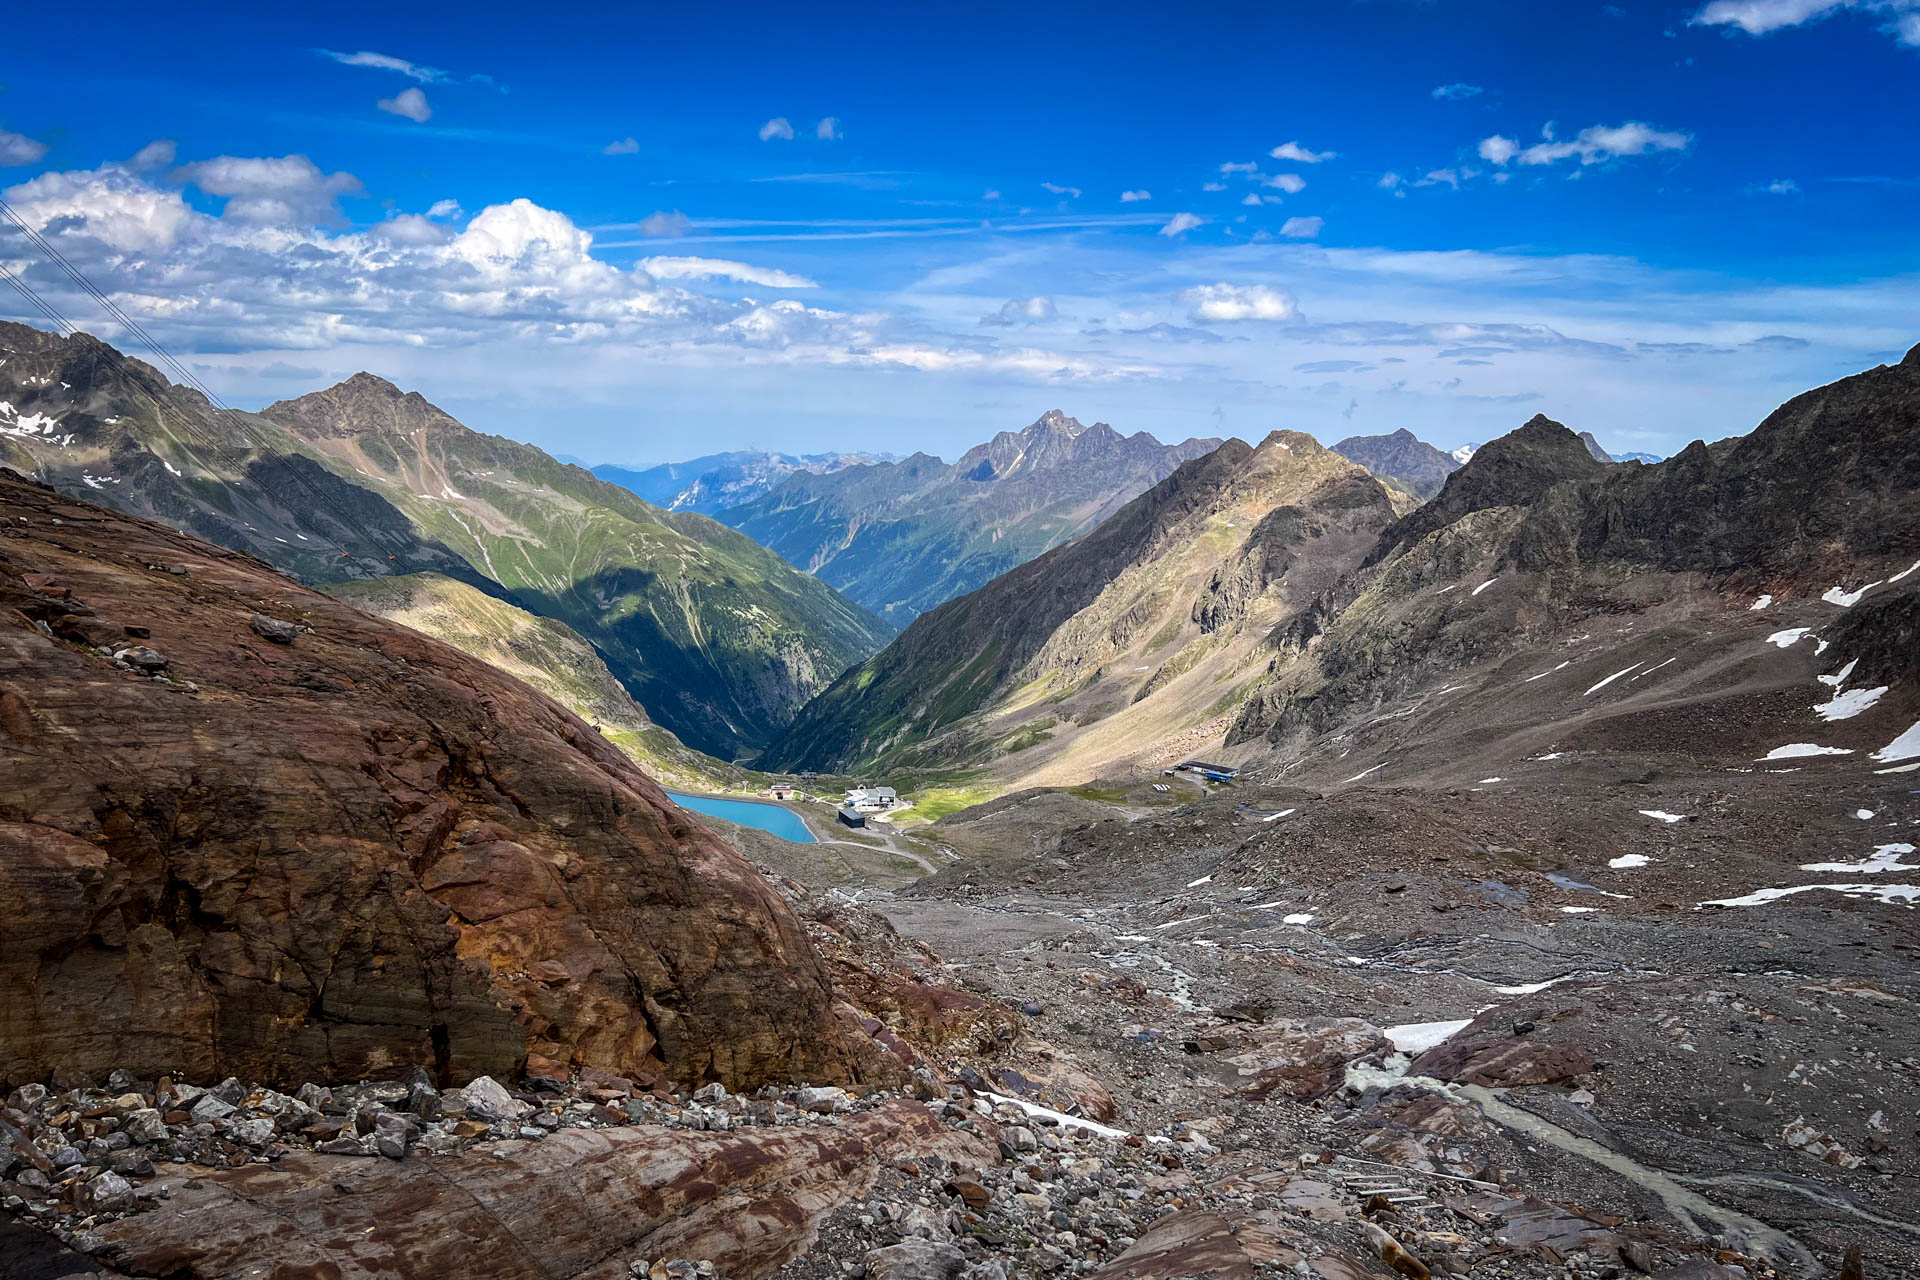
[0,0,1920,462]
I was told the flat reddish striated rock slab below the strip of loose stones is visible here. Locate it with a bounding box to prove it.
[86,1102,993,1280]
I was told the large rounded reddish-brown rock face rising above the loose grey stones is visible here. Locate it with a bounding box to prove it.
[0,472,885,1088]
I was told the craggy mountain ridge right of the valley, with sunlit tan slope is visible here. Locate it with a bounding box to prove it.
[764,349,1920,787]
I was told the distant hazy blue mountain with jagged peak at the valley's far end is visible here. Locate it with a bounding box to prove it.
[718,409,1219,626]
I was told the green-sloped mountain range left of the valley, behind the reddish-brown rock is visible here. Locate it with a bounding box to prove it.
[0,324,889,758]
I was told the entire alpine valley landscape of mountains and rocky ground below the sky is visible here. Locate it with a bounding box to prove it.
[0,322,1920,1280]
